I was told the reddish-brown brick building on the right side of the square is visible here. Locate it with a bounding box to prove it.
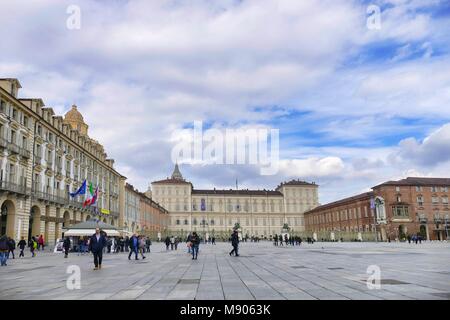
[305,177,450,241]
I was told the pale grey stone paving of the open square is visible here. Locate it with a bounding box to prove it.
[0,242,450,300]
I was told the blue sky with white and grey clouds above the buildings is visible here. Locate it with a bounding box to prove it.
[0,0,450,203]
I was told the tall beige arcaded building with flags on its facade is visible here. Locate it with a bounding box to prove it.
[0,79,125,244]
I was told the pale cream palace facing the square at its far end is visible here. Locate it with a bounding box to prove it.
[148,164,318,237]
